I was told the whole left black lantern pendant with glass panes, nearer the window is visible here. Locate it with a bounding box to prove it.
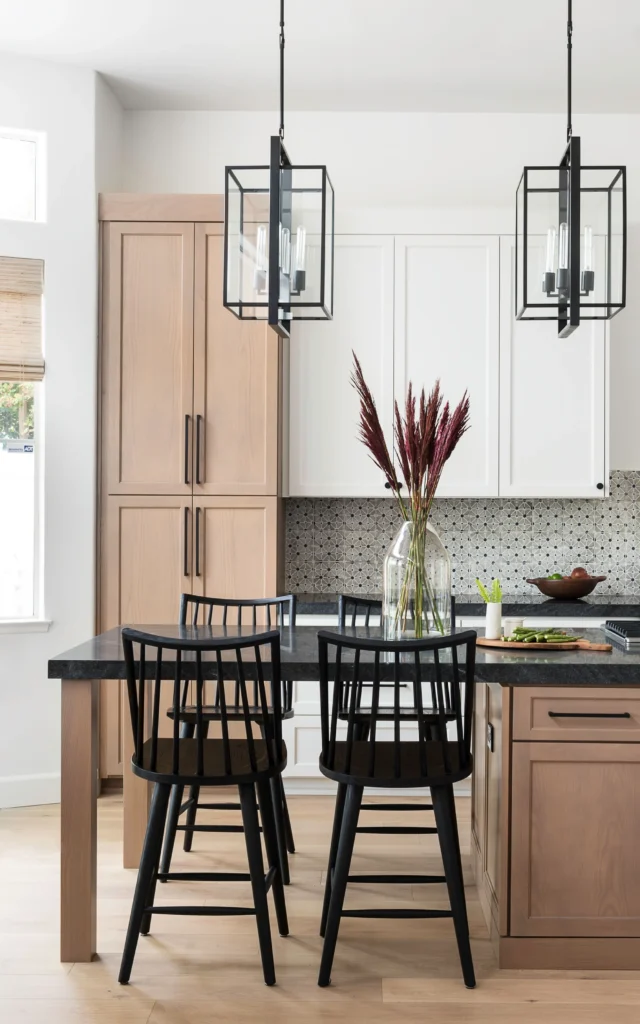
[223,0,334,338]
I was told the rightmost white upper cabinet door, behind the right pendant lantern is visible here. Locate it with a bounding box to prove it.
[500,238,608,498]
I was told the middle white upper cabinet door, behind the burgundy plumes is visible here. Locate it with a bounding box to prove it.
[394,234,500,498]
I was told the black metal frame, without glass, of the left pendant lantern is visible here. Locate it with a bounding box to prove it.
[223,0,335,338]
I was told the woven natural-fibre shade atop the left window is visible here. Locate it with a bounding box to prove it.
[0,256,44,381]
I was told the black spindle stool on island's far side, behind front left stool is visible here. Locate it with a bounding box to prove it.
[161,594,296,885]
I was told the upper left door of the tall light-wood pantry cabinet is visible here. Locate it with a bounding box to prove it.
[102,223,194,495]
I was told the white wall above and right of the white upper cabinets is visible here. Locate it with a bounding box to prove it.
[123,111,640,469]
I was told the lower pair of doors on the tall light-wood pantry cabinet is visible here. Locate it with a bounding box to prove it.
[99,495,281,778]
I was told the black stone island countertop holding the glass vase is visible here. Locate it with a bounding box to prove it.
[49,626,640,687]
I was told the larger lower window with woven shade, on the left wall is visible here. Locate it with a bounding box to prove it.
[0,257,44,620]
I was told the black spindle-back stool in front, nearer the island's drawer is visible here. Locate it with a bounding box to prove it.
[318,630,476,988]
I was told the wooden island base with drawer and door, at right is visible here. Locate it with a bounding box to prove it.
[471,683,640,970]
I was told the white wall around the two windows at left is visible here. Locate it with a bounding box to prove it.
[0,56,122,807]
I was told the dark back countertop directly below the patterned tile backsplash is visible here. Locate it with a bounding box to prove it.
[296,594,640,618]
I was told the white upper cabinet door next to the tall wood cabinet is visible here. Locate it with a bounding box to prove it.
[289,236,393,498]
